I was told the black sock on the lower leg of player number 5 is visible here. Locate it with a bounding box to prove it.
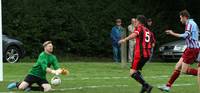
[131,71,147,86]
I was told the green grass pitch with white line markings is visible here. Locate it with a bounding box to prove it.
[0,62,198,93]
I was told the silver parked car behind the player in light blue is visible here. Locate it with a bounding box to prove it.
[159,40,187,60]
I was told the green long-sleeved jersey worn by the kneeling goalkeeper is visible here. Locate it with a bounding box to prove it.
[29,52,60,79]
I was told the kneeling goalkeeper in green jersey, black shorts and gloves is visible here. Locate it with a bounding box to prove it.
[7,41,68,92]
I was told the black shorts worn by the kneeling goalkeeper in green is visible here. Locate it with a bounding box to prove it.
[24,75,48,87]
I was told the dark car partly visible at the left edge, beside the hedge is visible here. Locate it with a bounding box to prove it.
[2,35,25,63]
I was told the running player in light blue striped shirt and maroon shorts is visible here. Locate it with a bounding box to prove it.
[158,10,200,92]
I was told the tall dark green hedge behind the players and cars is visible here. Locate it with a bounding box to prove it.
[2,0,200,57]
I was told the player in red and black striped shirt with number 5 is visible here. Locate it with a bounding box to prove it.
[119,15,155,93]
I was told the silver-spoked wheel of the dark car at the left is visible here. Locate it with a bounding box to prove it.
[5,46,20,63]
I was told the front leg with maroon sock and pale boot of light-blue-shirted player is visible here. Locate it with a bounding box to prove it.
[158,57,183,92]
